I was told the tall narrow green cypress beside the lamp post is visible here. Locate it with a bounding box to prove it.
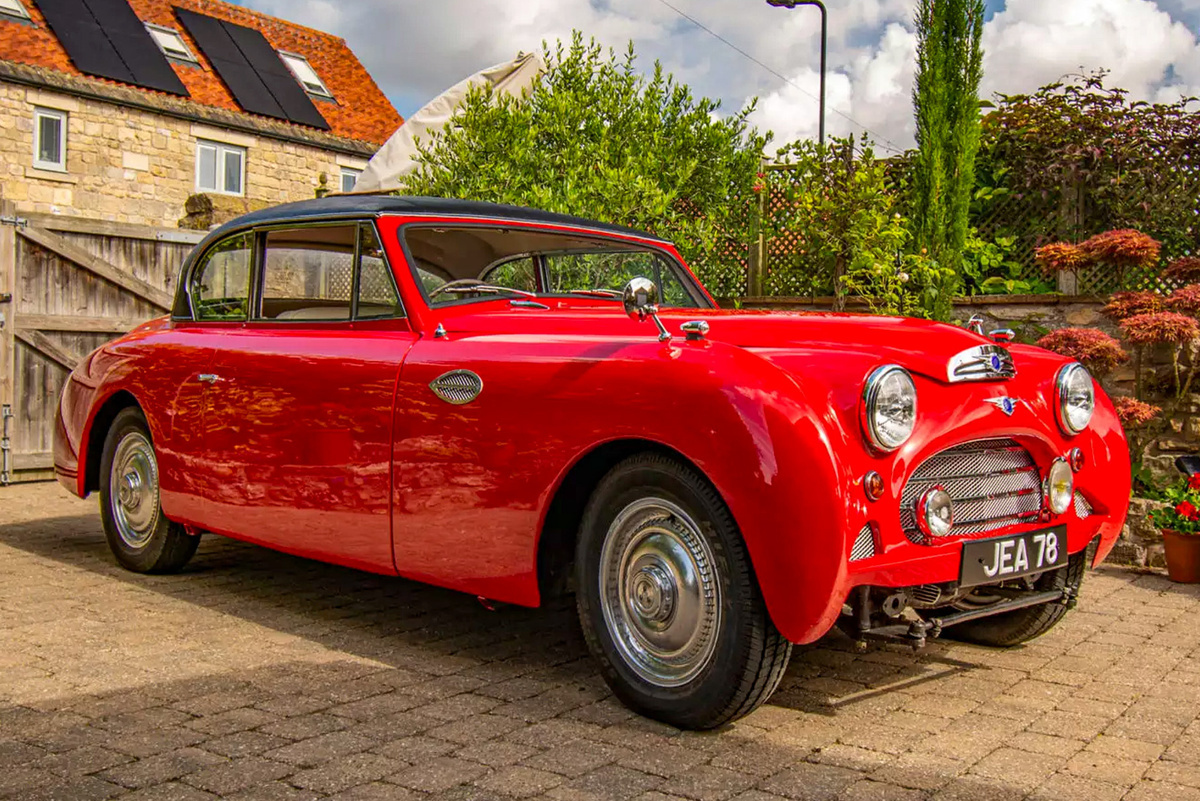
[912,0,984,319]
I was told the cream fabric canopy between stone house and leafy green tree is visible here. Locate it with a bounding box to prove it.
[354,53,546,193]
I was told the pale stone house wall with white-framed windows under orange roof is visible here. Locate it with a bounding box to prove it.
[0,82,366,227]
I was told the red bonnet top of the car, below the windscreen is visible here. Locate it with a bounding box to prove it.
[445,305,990,381]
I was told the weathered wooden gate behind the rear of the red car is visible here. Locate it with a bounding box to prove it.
[0,203,203,484]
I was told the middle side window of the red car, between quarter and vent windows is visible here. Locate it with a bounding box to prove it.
[260,225,358,323]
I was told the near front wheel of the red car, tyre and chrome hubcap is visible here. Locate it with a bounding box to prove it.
[576,454,792,729]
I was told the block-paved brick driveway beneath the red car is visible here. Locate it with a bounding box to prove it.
[0,484,1200,801]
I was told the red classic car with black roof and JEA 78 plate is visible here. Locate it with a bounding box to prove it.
[54,195,1130,728]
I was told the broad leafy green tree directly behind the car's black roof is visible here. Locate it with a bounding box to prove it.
[404,32,767,296]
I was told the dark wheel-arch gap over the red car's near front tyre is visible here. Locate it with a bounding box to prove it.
[536,438,732,601]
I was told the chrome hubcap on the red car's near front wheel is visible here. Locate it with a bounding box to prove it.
[600,498,721,687]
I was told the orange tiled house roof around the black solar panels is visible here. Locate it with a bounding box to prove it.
[0,0,403,145]
